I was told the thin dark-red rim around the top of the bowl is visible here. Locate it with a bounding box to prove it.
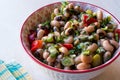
[20,1,120,74]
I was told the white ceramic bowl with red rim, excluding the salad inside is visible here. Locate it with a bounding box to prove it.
[20,1,120,80]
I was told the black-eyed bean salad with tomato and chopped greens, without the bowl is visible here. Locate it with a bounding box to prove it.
[28,2,119,70]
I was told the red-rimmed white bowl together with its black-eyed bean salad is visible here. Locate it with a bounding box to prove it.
[20,1,120,80]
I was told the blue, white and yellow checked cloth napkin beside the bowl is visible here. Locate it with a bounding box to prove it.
[0,60,32,80]
